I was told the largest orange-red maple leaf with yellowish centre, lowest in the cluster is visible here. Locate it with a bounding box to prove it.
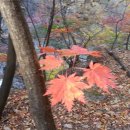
[45,74,89,111]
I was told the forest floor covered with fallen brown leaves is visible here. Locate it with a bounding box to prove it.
[0,46,130,130]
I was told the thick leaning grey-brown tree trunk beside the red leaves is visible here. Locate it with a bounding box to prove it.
[0,0,56,130]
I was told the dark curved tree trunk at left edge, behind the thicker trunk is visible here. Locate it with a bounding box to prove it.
[0,36,16,117]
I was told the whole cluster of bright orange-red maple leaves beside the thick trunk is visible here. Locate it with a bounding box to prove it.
[39,45,116,111]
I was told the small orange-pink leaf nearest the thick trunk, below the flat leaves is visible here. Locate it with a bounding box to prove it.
[39,55,64,70]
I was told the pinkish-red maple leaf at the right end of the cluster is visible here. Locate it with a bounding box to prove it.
[84,61,116,92]
